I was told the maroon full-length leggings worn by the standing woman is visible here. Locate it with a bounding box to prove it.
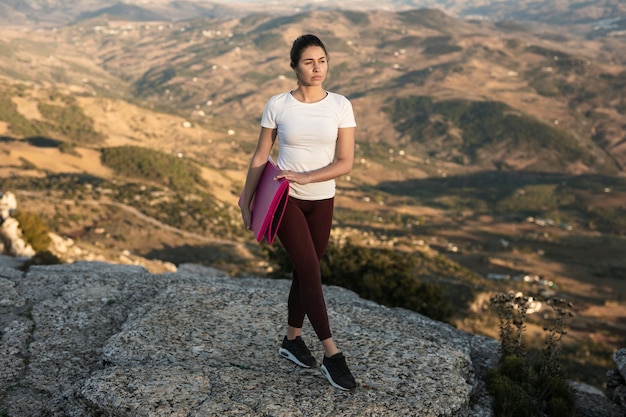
[278,197,335,340]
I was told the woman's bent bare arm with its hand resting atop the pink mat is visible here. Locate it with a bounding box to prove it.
[276,127,356,184]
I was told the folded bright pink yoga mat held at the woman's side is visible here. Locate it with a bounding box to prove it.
[239,158,289,244]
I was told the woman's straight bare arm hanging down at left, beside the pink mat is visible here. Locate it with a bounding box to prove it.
[241,127,276,229]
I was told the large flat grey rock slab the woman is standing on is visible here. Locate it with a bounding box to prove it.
[0,262,498,417]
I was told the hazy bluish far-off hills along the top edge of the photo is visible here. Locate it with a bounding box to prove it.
[0,0,626,30]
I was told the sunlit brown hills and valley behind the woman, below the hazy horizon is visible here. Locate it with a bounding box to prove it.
[0,3,626,392]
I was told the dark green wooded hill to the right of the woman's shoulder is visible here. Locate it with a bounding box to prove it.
[388,97,604,172]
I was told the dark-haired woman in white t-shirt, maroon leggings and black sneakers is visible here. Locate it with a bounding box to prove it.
[241,34,356,390]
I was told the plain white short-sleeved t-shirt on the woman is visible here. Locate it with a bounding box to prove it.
[261,92,356,200]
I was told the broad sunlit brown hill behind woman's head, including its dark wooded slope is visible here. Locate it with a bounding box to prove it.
[0,7,626,174]
